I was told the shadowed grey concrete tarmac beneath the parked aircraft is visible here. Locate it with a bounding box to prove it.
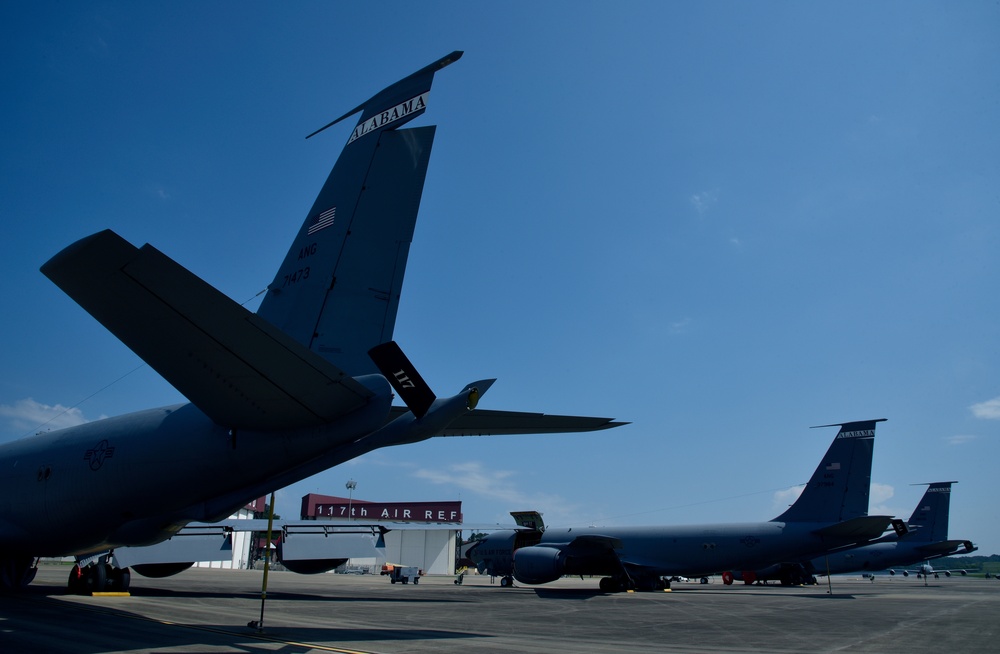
[0,566,1000,654]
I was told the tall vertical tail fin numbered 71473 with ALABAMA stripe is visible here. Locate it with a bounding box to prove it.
[257,51,462,375]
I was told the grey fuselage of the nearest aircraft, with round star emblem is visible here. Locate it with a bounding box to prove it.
[0,375,391,556]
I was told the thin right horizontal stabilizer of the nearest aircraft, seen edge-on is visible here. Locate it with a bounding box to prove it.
[389,406,629,436]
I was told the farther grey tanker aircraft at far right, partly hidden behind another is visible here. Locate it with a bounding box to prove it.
[744,481,978,583]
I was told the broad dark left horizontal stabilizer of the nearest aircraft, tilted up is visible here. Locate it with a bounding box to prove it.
[42,230,371,430]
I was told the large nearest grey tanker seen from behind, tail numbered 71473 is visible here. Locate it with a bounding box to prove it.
[0,52,623,590]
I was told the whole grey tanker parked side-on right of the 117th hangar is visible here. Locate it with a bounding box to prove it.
[468,420,901,591]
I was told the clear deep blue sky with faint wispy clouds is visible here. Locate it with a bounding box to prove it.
[0,1,1000,554]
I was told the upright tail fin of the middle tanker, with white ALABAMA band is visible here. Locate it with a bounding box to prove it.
[772,418,885,522]
